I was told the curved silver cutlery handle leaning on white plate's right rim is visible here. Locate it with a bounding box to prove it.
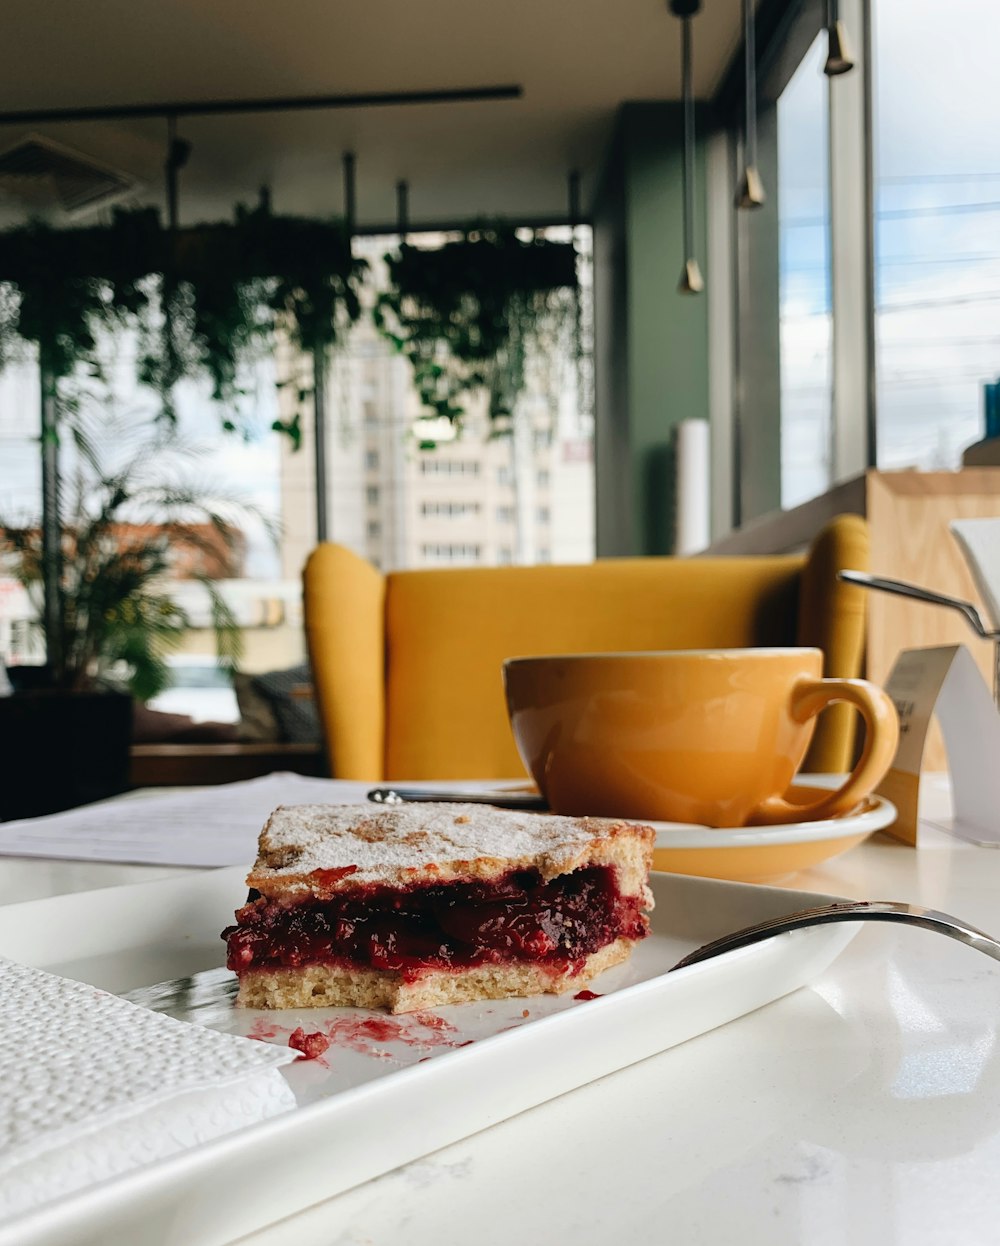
[667,900,1000,973]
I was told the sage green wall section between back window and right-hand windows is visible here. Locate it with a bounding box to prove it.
[593,102,709,557]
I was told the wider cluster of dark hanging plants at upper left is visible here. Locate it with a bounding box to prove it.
[0,194,365,440]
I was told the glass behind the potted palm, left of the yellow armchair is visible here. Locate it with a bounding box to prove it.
[0,313,295,722]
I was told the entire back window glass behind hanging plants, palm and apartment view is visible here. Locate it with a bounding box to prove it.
[0,228,594,727]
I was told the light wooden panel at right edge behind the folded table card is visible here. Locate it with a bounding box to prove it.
[866,467,1000,770]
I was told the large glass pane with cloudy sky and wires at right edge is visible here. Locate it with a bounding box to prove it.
[874,0,1000,468]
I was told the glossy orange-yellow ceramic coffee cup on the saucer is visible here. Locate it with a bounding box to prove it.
[503,648,899,826]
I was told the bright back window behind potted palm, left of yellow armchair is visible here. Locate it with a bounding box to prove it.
[0,331,301,697]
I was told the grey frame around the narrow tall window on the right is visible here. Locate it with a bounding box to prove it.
[706,0,877,538]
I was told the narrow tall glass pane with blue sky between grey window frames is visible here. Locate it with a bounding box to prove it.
[778,34,833,507]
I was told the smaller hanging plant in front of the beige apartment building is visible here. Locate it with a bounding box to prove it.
[375,226,578,424]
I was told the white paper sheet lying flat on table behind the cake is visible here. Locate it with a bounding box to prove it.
[0,774,381,866]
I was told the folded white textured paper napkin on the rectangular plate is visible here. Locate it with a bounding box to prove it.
[0,958,296,1224]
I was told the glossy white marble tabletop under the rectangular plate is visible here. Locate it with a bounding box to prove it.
[0,777,1000,1246]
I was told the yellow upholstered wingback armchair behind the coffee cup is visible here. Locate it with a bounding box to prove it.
[304,515,868,781]
